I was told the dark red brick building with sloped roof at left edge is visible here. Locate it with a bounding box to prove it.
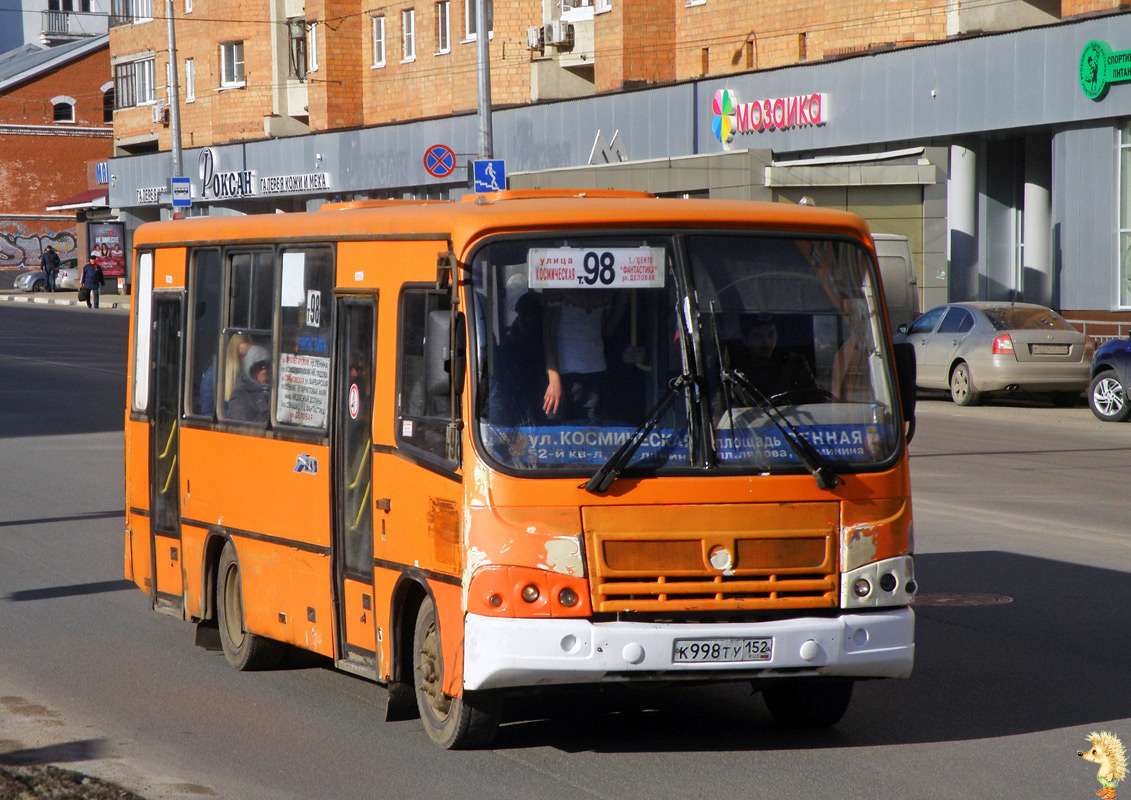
[0,36,113,278]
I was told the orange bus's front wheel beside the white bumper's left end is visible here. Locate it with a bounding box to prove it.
[413,597,499,750]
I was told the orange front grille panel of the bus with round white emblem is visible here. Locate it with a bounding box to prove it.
[582,502,839,612]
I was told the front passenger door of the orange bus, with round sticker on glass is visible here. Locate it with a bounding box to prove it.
[330,296,378,677]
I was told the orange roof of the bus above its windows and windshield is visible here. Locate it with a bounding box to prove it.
[133,190,870,253]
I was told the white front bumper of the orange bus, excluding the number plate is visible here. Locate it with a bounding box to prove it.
[464,608,915,690]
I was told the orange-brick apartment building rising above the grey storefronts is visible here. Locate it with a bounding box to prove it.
[110,0,1125,148]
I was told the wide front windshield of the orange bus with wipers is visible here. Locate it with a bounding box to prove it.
[472,232,899,475]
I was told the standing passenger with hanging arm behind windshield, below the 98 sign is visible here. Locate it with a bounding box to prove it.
[542,289,627,422]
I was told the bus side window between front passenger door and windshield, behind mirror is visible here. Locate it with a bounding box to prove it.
[397,287,451,459]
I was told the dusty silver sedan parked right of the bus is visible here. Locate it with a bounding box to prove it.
[895,302,1094,405]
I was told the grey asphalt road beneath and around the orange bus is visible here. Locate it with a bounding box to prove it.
[0,303,1131,800]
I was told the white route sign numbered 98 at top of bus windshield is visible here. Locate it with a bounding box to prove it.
[527,247,665,289]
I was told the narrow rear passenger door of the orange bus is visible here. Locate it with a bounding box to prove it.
[149,294,184,613]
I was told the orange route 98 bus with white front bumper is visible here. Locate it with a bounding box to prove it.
[124,191,916,748]
